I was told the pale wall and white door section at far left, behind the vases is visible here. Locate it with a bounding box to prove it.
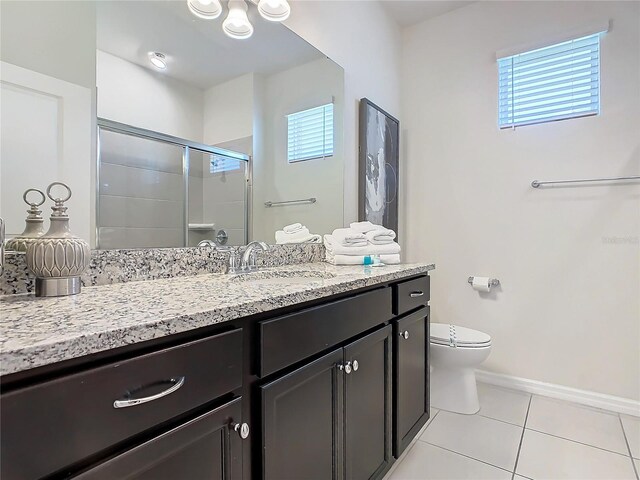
[0,1,96,244]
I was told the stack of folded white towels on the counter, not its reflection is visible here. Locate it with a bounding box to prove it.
[324,222,400,265]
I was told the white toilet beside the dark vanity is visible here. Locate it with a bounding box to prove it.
[429,323,491,415]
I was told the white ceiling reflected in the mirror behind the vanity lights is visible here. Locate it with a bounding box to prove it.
[97,0,324,89]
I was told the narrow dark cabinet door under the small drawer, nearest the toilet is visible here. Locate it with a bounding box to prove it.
[393,307,429,458]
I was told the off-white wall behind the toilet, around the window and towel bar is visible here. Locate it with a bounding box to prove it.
[401,1,640,400]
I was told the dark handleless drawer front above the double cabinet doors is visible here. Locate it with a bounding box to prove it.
[259,288,392,376]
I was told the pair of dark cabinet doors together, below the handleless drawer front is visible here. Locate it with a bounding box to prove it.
[261,326,392,480]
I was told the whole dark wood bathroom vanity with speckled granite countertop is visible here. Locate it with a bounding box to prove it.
[0,263,434,480]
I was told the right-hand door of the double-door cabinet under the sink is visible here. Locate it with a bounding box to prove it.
[344,325,392,480]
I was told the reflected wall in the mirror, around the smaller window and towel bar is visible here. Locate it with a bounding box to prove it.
[253,58,344,243]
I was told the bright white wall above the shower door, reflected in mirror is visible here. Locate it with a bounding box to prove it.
[96,50,204,142]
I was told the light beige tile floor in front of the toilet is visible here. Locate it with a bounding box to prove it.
[385,384,640,480]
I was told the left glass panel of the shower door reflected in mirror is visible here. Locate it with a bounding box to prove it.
[96,128,187,249]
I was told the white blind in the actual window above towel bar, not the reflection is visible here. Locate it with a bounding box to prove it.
[498,33,600,128]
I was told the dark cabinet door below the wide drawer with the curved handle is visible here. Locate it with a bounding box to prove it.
[78,398,242,480]
